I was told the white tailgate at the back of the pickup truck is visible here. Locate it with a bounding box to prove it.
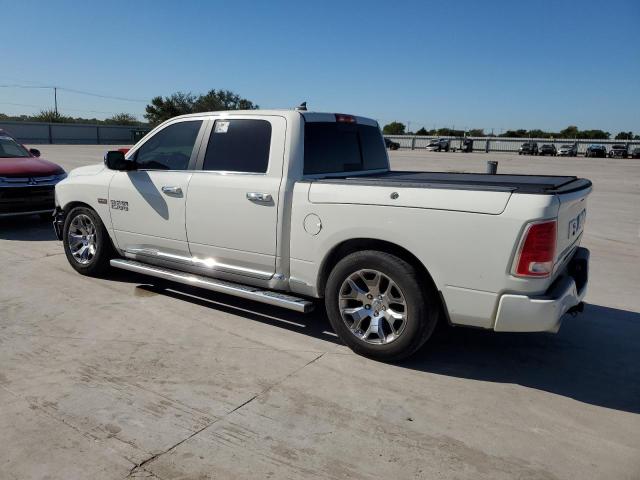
[555,187,591,264]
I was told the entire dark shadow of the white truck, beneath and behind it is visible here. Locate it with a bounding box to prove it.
[112,278,640,413]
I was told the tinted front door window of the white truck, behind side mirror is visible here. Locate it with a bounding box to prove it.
[136,120,202,170]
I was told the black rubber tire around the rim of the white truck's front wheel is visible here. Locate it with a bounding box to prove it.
[62,207,115,277]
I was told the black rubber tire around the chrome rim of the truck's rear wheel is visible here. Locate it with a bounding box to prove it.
[325,250,440,362]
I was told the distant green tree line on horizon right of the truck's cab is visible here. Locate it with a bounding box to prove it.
[382,122,640,140]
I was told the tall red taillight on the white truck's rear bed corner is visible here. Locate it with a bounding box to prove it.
[514,220,557,277]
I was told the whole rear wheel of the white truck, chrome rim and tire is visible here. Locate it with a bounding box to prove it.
[325,250,440,361]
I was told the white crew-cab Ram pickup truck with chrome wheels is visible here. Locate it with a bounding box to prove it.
[54,110,591,360]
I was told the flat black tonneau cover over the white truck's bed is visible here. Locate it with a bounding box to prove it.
[317,171,591,195]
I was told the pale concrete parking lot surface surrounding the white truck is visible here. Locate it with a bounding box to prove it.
[0,145,640,480]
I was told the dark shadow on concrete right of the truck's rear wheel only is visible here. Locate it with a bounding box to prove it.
[402,305,640,413]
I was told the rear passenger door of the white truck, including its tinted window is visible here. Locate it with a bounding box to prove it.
[186,115,286,279]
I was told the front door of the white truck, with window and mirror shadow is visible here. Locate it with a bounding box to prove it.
[109,119,205,260]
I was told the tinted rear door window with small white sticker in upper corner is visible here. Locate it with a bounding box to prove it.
[203,120,271,173]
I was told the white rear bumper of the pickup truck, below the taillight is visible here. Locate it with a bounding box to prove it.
[494,248,589,332]
